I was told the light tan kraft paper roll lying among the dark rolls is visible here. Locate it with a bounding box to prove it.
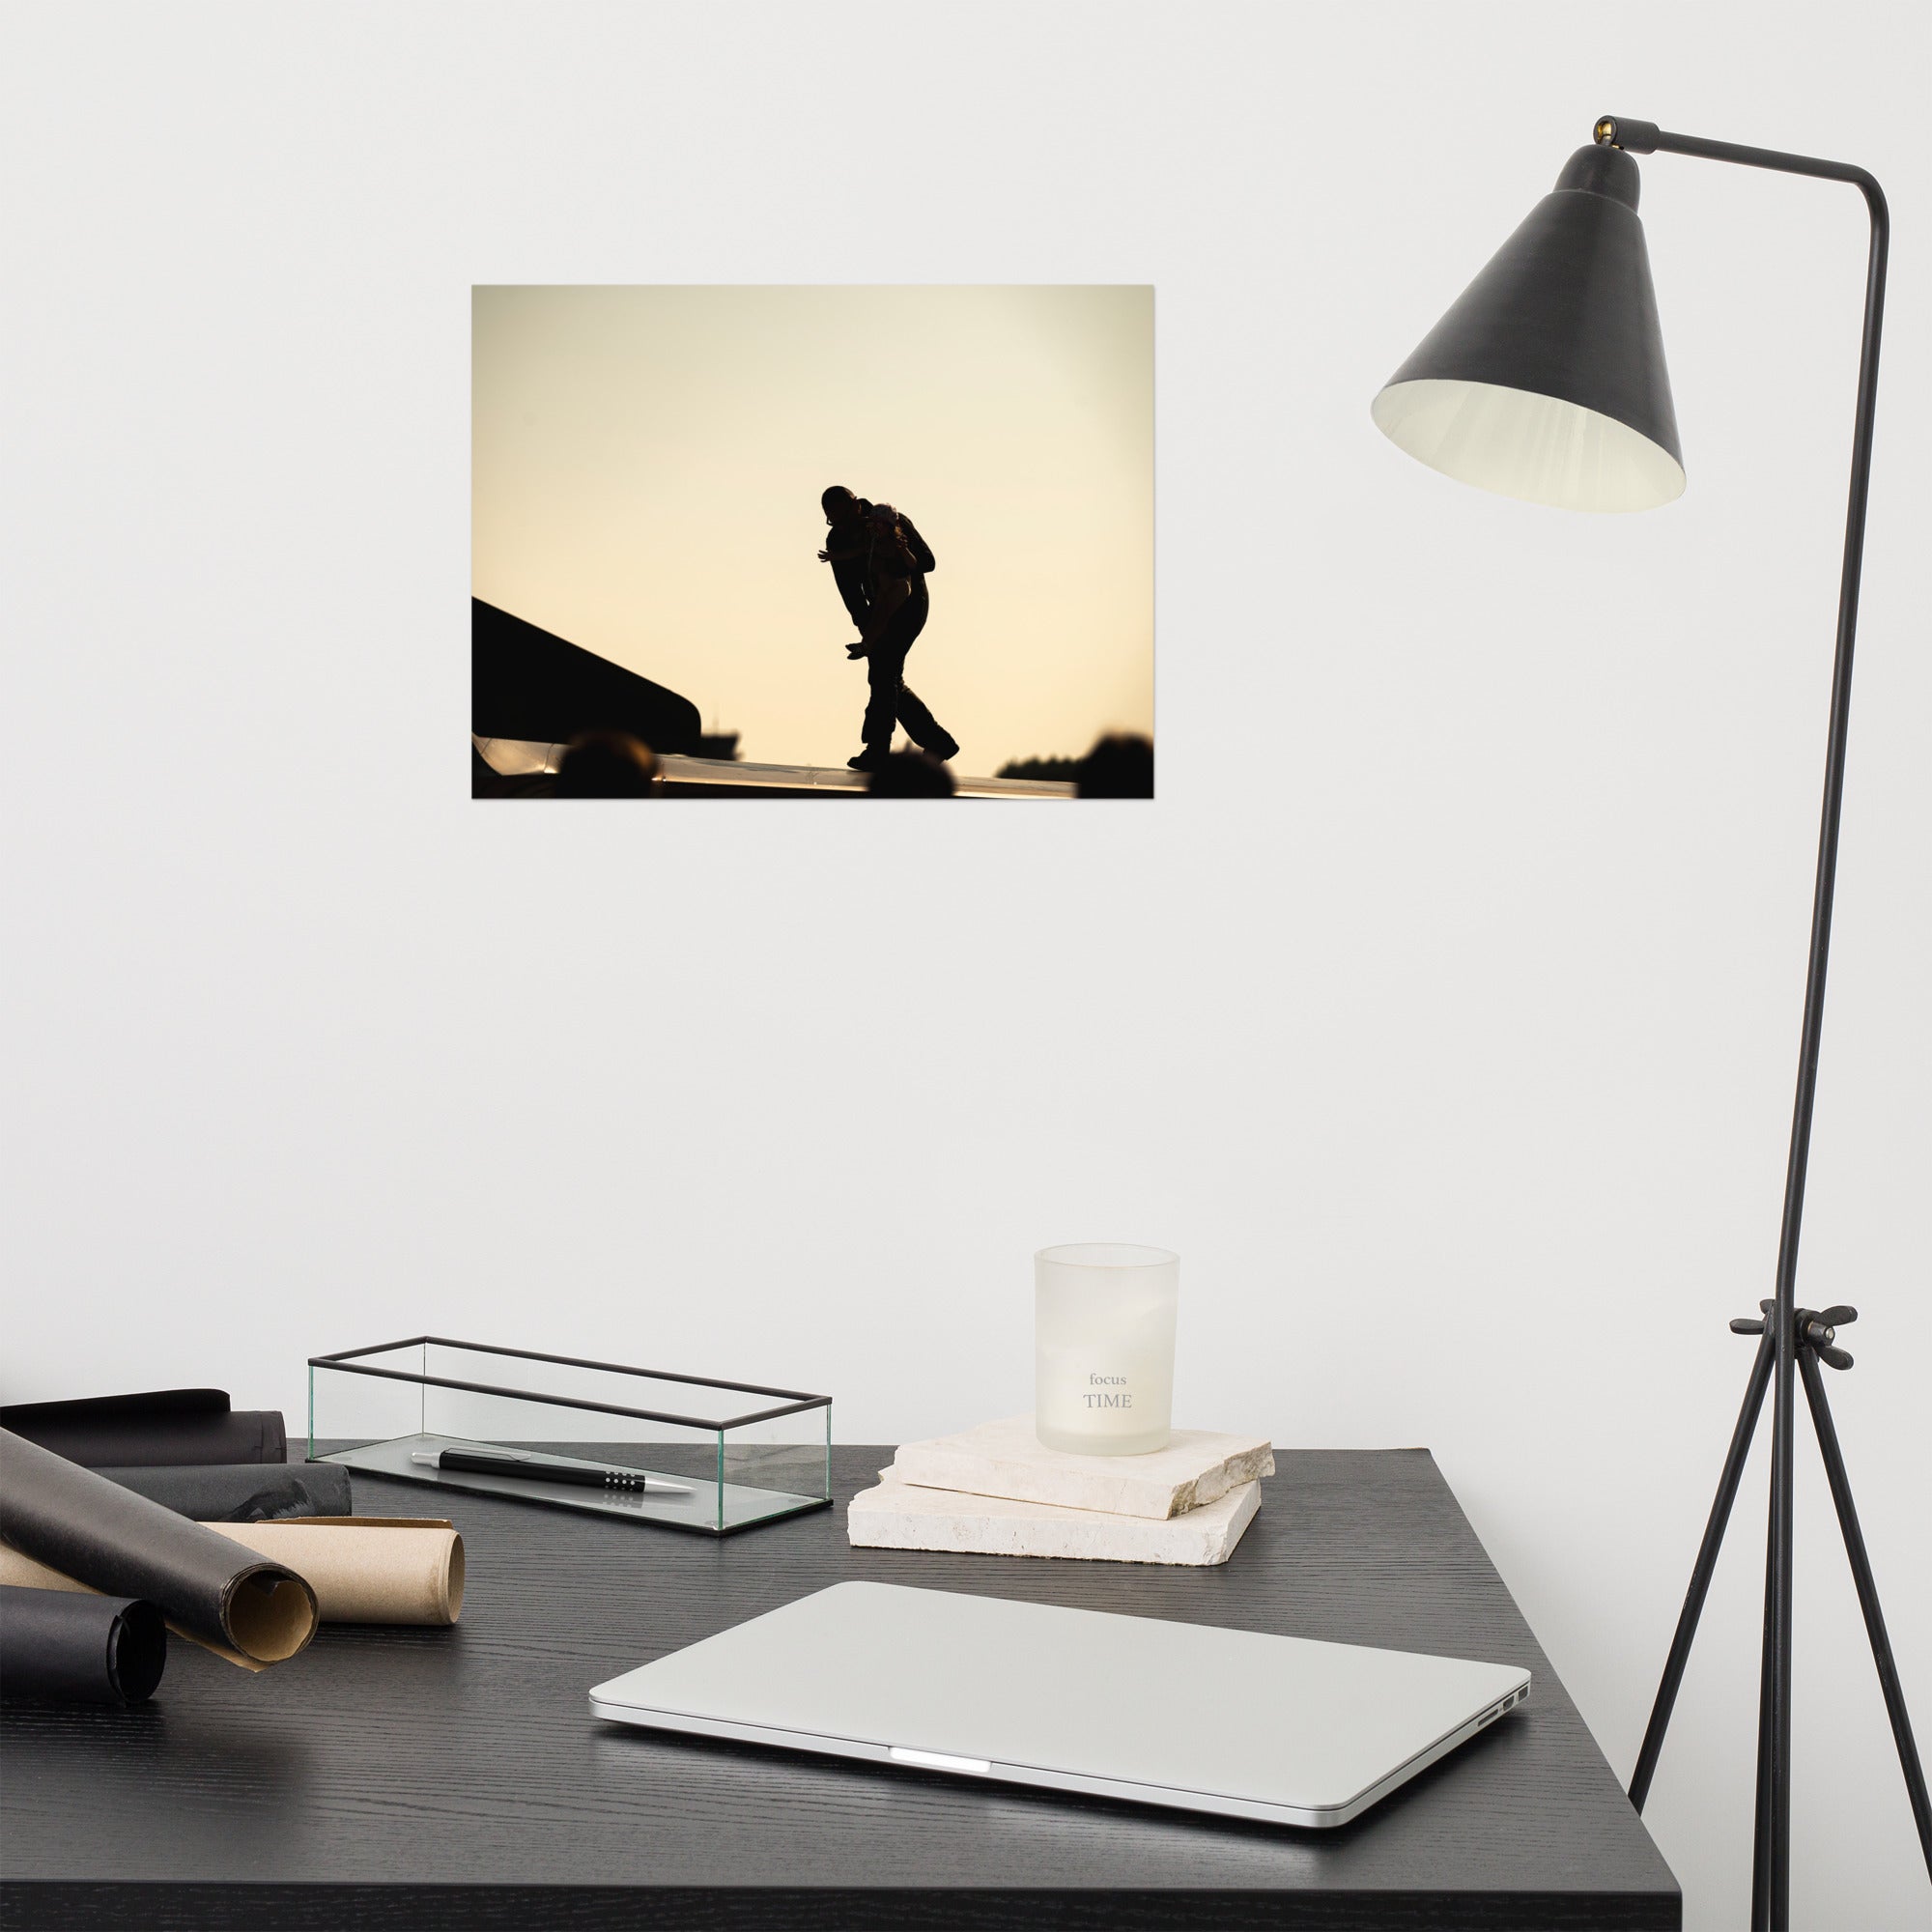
[209,1517,464,1623]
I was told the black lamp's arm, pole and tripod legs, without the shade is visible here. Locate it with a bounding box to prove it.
[1596,114,1932,1932]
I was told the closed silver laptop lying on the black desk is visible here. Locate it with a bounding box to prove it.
[591,1582,1530,1826]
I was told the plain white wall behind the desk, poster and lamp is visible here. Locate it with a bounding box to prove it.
[0,4,1932,1928]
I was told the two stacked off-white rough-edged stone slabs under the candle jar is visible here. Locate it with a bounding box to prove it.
[846,1416,1275,1565]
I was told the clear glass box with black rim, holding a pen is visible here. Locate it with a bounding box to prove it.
[309,1335,833,1536]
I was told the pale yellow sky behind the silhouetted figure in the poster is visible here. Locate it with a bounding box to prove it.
[471,288,1153,775]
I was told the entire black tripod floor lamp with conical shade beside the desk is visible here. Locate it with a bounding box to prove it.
[1374,116,1932,1932]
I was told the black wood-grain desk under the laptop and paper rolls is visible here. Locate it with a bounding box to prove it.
[0,1449,1679,1932]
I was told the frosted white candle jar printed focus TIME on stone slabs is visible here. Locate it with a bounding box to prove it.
[1034,1240,1180,1455]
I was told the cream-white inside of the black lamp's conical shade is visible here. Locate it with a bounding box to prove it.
[1372,377,1685,510]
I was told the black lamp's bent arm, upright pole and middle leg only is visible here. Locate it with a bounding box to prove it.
[1596,114,1891,1932]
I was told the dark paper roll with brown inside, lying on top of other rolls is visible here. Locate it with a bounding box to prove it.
[0,1430,315,1669]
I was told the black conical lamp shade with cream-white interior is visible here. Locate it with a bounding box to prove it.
[1372,147,1685,510]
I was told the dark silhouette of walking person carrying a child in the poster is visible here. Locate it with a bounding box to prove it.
[819,483,958,771]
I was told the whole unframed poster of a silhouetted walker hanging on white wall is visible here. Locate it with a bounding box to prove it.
[469,286,1153,800]
